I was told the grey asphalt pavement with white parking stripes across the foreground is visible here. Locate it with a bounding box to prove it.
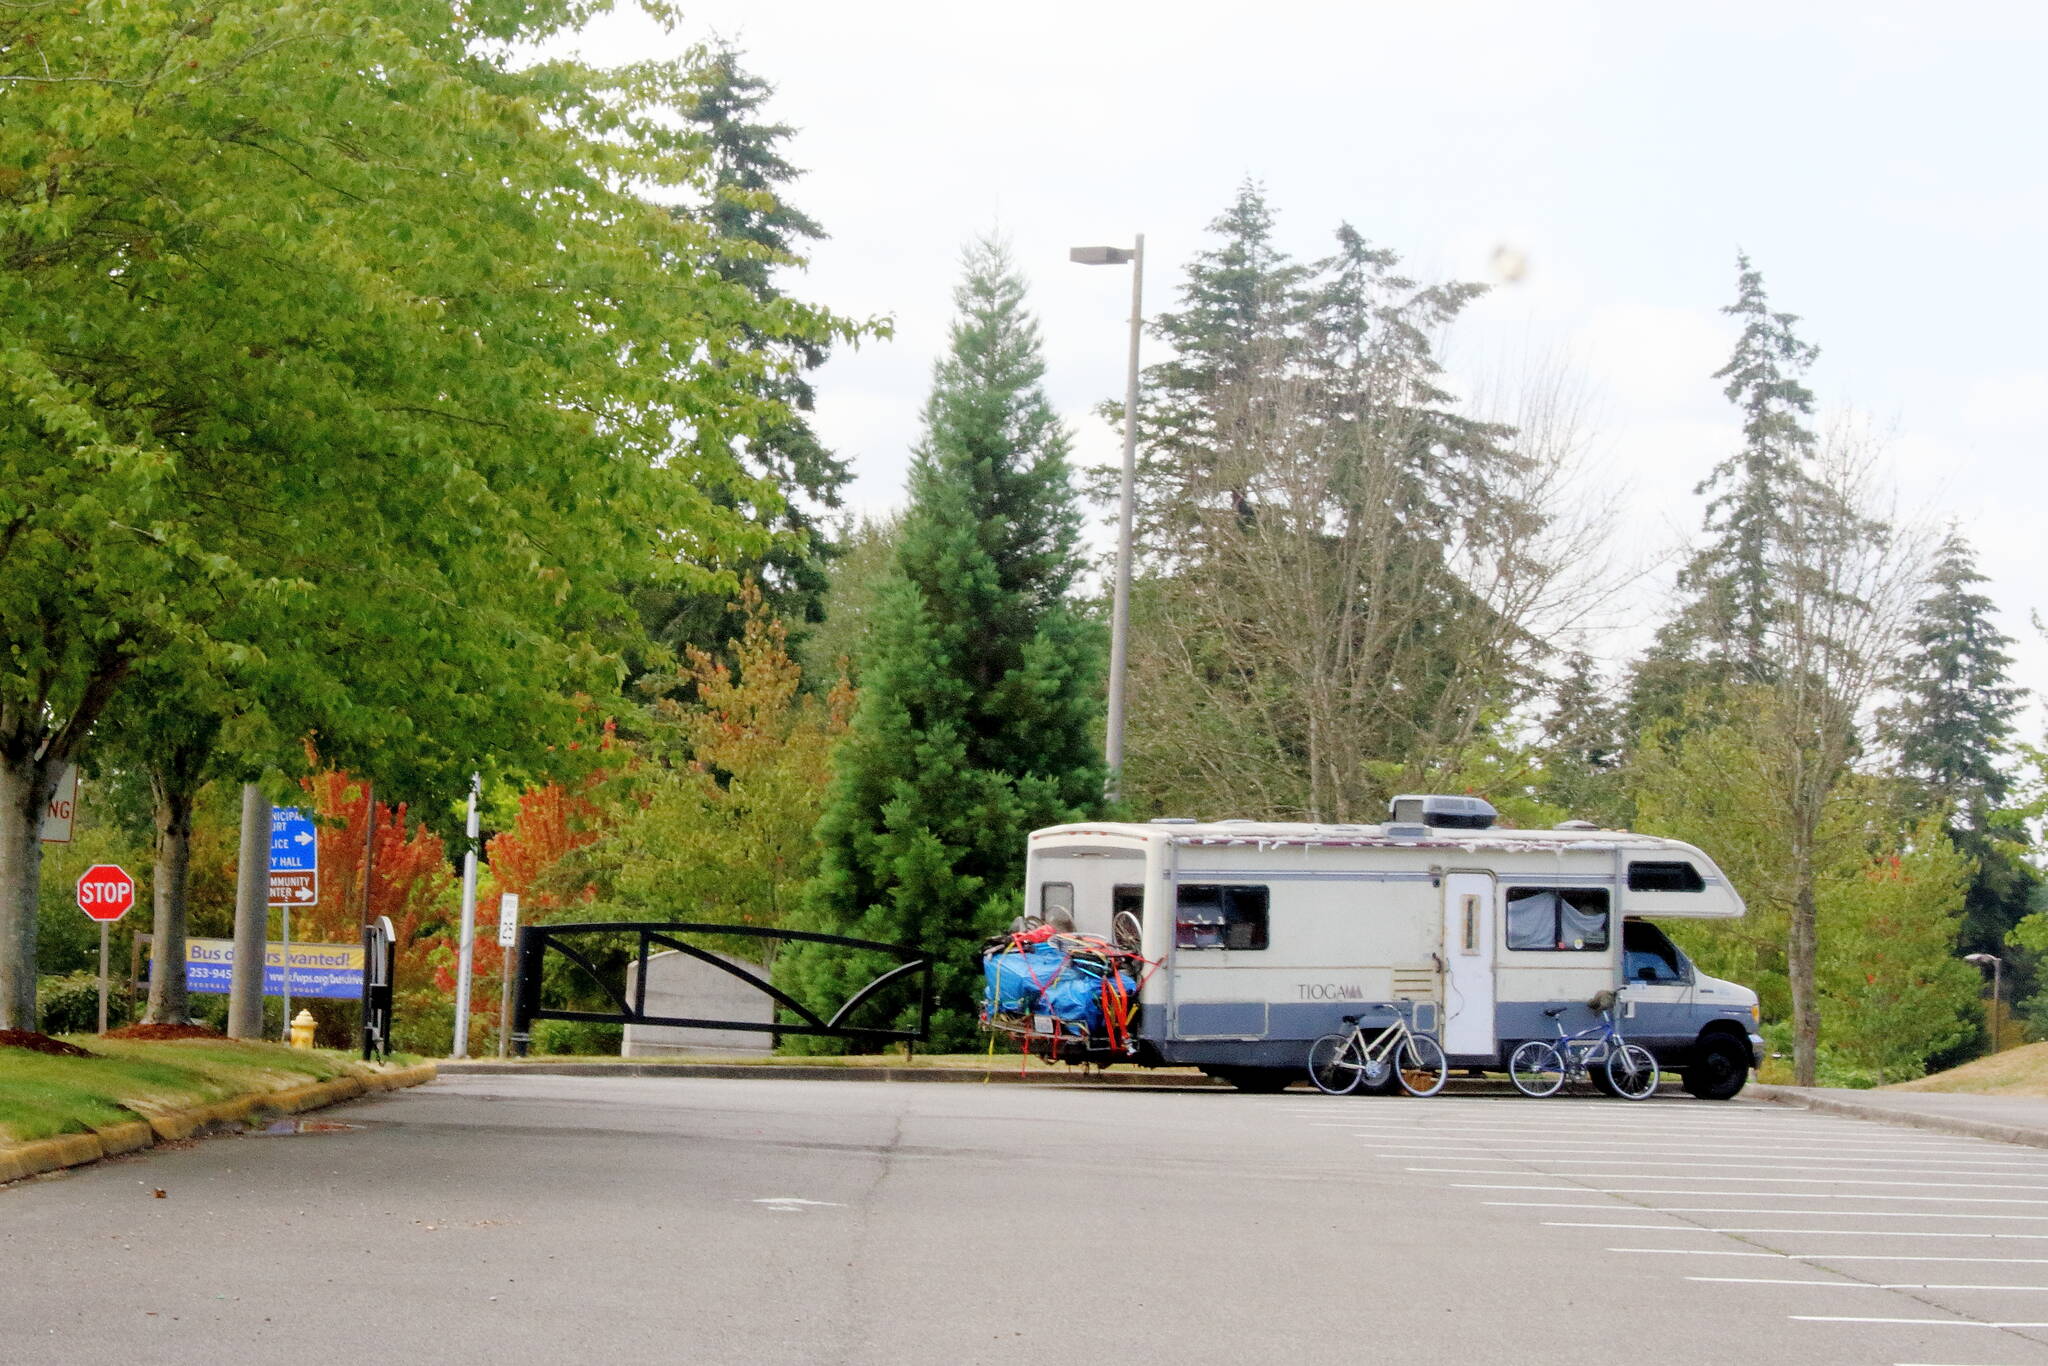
[12,1075,2048,1366]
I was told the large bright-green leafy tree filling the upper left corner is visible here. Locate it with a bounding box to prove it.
[0,0,846,1026]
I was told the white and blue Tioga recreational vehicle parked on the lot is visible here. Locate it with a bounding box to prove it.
[1024,797,1763,1100]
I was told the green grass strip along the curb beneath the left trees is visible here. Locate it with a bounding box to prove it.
[0,1034,415,1143]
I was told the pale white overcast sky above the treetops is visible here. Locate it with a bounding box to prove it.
[565,0,2048,716]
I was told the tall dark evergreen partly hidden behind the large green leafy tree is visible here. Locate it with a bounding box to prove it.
[639,43,852,686]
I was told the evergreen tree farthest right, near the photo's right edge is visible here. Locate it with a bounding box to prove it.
[1882,528,2040,962]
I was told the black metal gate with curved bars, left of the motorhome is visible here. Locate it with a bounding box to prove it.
[512,920,932,1057]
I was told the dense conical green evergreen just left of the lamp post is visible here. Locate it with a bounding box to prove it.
[778,244,1104,1044]
